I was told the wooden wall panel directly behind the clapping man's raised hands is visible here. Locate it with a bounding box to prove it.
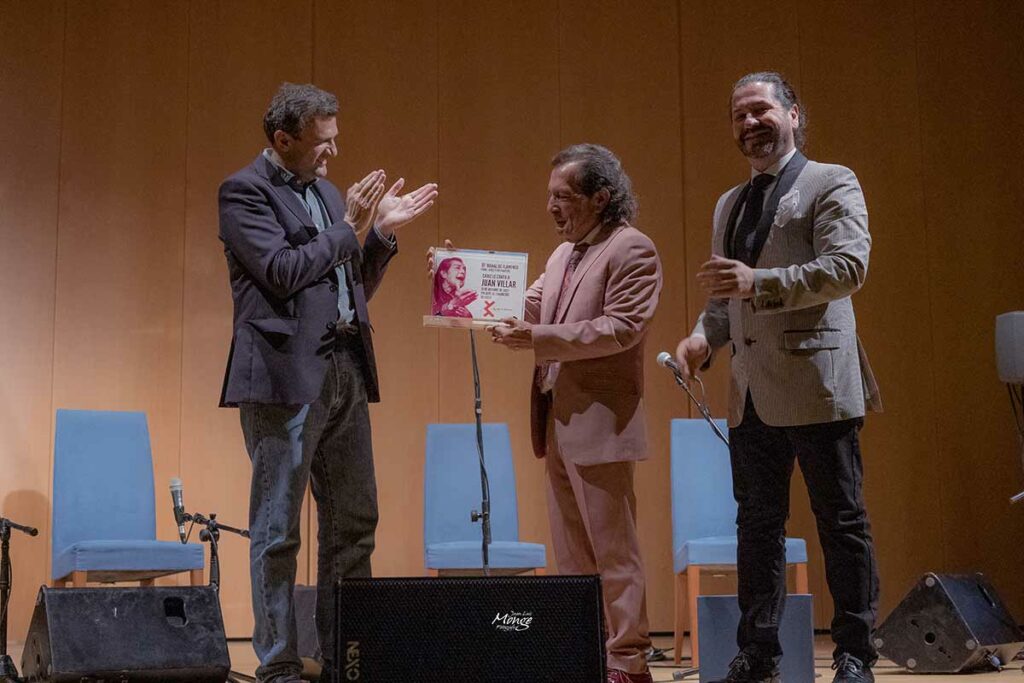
[309,0,444,580]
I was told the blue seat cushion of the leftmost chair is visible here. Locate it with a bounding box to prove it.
[51,540,204,579]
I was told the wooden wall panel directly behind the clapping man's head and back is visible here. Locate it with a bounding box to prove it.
[182,0,313,637]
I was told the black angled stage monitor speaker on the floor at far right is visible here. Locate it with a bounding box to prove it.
[874,573,1024,674]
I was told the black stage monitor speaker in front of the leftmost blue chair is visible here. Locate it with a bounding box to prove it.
[22,586,230,683]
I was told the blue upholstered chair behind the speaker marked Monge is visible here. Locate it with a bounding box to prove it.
[423,424,547,574]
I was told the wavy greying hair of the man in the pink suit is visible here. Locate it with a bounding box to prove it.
[551,143,640,224]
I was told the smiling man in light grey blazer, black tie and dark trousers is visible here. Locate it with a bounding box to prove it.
[677,72,882,683]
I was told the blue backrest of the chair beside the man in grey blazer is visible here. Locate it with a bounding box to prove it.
[672,420,736,551]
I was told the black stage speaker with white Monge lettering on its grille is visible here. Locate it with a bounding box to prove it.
[335,577,605,683]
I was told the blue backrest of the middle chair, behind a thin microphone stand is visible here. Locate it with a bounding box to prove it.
[423,424,519,544]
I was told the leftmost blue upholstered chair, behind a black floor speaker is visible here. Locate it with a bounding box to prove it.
[50,410,204,587]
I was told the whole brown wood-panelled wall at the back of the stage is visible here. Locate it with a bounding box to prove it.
[0,0,1024,640]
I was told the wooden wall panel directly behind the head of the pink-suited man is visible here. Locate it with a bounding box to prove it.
[559,0,687,624]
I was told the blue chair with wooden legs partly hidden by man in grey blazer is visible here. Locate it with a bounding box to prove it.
[672,420,807,667]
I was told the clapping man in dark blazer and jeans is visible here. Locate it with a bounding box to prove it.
[219,83,437,683]
